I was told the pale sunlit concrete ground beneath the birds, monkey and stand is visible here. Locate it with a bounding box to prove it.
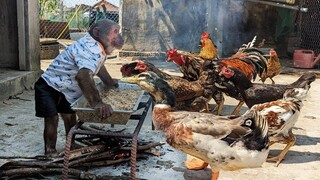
[0,59,320,180]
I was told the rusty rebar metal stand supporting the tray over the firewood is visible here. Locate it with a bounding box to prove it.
[62,95,153,180]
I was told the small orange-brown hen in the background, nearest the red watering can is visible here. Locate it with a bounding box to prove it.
[260,49,281,84]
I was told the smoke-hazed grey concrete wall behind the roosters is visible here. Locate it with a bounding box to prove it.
[121,0,275,56]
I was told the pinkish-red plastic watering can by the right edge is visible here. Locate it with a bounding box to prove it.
[293,50,318,68]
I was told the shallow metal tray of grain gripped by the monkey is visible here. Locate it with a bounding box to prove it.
[71,82,144,124]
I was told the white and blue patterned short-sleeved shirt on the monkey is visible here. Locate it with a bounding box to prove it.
[41,34,106,104]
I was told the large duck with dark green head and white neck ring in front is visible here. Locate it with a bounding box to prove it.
[120,71,269,179]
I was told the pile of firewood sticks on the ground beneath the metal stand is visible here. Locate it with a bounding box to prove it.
[0,126,164,179]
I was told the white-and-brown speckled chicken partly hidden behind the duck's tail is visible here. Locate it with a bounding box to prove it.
[250,83,310,166]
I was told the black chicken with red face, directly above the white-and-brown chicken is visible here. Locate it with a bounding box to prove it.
[216,66,316,108]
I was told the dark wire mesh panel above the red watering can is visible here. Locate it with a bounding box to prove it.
[300,0,320,54]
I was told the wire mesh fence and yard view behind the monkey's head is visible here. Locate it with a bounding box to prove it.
[39,0,120,40]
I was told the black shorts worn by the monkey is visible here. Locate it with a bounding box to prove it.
[34,77,75,117]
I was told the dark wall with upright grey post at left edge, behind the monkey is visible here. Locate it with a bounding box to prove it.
[0,0,40,71]
